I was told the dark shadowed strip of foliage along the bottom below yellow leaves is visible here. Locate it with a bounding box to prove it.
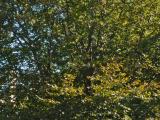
[0,96,160,120]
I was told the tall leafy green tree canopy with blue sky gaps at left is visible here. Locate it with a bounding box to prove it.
[0,0,160,119]
